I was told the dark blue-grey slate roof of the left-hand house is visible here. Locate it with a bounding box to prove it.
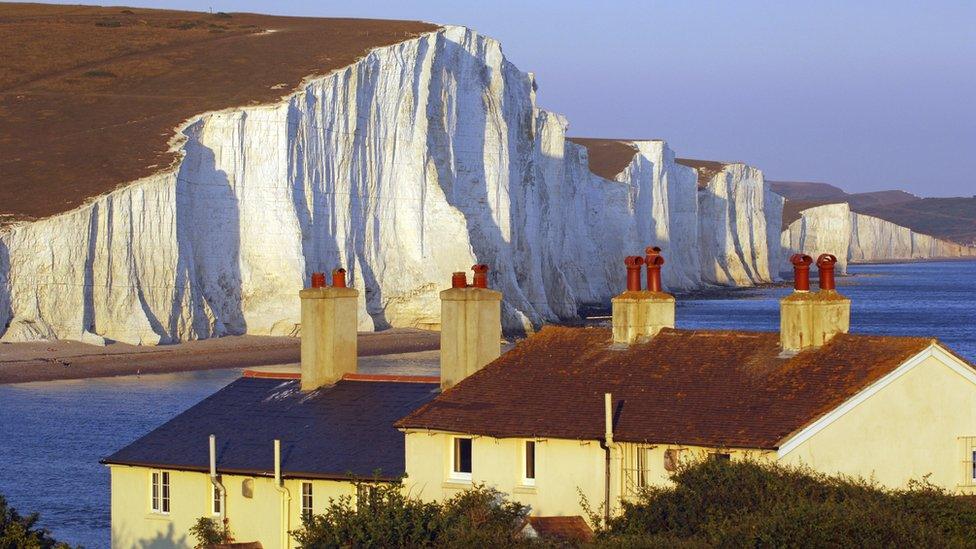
[102,377,439,479]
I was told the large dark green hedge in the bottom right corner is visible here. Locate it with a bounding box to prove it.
[598,460,976,547]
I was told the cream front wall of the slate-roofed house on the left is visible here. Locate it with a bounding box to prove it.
[110,465,356,549]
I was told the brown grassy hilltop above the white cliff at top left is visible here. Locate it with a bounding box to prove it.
[0,4,438,224]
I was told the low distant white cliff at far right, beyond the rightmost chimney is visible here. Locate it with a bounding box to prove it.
[782,203,976,272]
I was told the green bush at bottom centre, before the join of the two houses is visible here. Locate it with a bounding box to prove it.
[293,482,528,549]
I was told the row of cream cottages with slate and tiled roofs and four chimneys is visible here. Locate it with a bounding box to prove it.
[103,248,976,548]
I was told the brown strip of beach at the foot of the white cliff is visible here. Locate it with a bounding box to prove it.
[0,328,440,384]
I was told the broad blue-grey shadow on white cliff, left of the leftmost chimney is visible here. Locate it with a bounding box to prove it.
[168,121,247,339]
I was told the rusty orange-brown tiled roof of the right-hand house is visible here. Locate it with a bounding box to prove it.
[397,326,934,449]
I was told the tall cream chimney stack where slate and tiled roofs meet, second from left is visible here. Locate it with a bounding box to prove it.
[441,265,502,390]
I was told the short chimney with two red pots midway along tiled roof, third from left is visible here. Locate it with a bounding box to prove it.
[612,247,675,345]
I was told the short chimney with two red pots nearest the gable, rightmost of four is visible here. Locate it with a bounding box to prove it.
[780,254,851,353]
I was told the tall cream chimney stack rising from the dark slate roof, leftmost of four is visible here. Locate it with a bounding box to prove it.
[299,269,359,391]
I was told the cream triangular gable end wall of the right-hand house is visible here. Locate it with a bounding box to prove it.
[781,348,976,493]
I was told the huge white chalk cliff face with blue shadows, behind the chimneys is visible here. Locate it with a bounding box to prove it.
[0,27,782,344]
